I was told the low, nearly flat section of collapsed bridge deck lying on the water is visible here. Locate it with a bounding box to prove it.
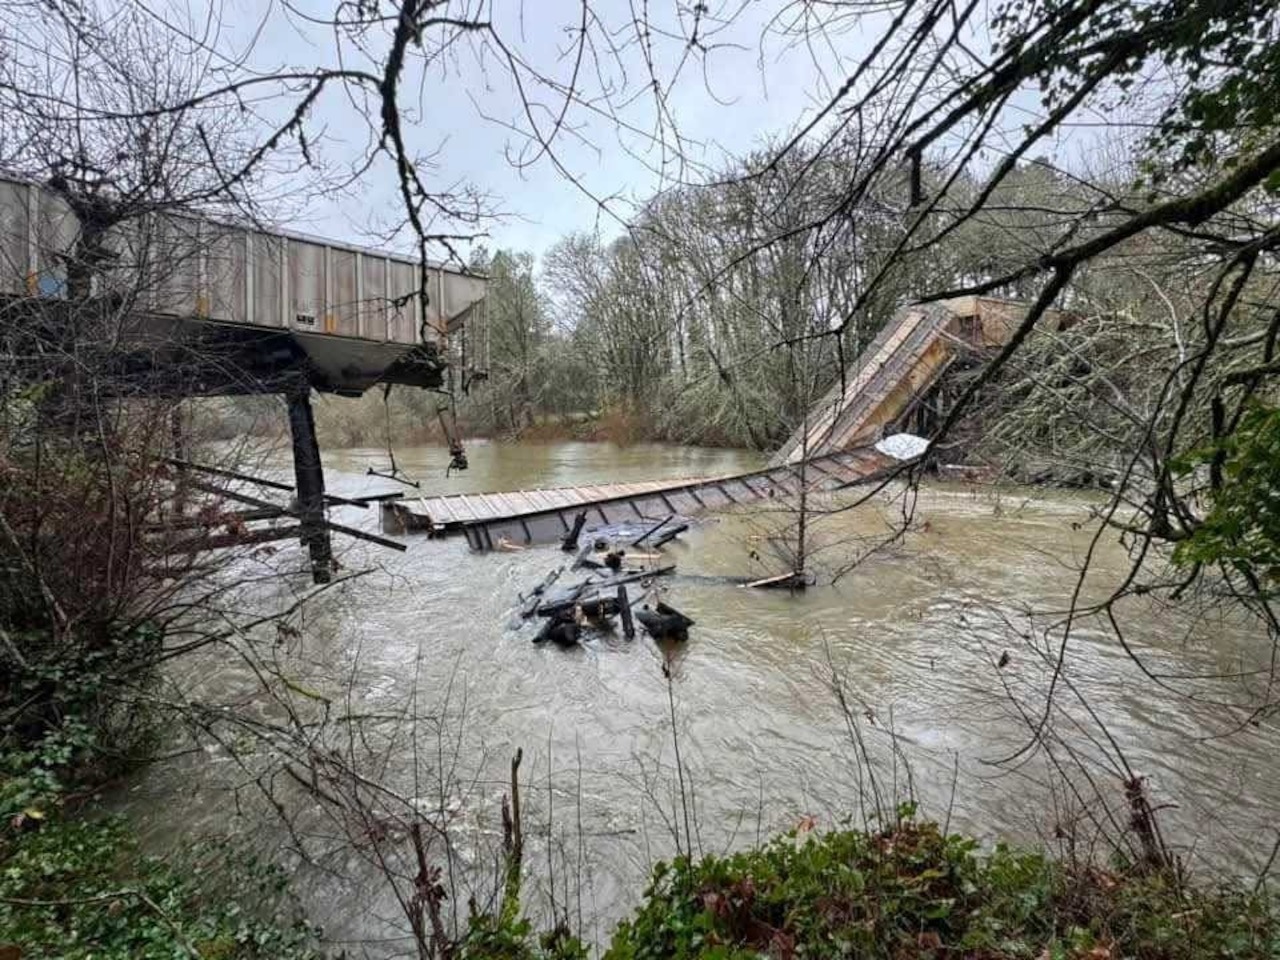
[383,448,896,550]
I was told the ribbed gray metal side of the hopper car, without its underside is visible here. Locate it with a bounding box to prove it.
[0,177,484,346]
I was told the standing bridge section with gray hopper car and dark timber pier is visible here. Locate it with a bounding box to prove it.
[0,177,485,581]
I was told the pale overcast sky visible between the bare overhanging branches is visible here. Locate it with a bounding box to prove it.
[209,0,874,253]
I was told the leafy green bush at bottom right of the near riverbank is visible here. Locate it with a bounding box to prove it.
[607,820,1280,960]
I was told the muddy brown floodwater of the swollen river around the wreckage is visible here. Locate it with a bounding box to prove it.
[122,443,1280,955]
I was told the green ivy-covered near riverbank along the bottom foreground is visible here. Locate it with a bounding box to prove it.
[0,808,1280,960]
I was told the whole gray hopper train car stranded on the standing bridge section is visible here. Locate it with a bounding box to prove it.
[0,177,485,393]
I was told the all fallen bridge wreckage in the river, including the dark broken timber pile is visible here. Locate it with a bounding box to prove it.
[396,297,1068,645]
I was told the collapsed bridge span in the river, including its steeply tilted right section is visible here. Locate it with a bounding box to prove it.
[381,297,1068,550]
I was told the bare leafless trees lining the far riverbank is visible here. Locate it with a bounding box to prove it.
[267,143,1259,488]
